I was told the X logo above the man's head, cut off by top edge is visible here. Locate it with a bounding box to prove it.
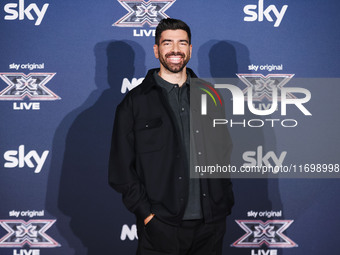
[113,0,176,27]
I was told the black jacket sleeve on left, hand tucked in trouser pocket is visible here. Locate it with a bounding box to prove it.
[109,98,151,219]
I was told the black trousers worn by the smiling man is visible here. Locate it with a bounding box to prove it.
[137,217,226,255]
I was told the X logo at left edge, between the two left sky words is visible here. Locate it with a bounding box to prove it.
[0,73,60,100]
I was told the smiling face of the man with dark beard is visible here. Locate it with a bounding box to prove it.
[154,29,192,73]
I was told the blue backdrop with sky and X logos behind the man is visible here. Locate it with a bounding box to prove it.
[0,0,340,255]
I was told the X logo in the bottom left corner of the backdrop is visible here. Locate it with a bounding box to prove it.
[0,220,60,248]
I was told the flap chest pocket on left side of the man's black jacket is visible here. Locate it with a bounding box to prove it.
[135,117,164,153]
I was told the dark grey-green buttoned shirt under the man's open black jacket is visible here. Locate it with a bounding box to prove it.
[154,72,203,220]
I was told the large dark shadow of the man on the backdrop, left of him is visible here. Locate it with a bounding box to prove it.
[46,41,145,255]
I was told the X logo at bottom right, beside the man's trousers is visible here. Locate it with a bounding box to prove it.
[231,220,298,248]
